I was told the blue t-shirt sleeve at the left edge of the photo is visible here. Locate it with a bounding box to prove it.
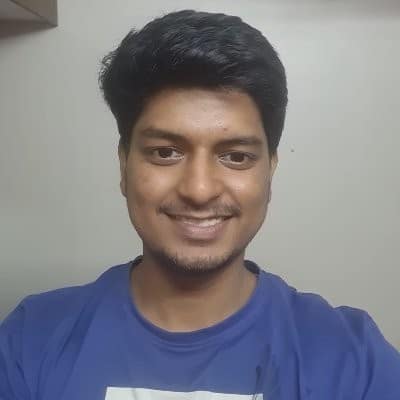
[0,304,31,400]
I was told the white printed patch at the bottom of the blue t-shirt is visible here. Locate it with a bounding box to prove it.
[104,387,263,400]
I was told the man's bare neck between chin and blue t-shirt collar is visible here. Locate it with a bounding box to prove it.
[131,254,256,332]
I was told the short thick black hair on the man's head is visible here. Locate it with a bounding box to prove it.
[99,10,287,154]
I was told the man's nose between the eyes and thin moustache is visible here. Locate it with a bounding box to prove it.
[178,153,223,207]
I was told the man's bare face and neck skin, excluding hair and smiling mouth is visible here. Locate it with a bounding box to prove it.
[118,88,277,332]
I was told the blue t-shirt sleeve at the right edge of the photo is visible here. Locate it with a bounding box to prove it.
[341,307,400,400]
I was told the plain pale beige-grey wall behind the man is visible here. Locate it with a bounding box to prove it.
[0,0,400,348]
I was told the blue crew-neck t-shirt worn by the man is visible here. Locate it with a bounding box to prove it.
[0,258,400,400]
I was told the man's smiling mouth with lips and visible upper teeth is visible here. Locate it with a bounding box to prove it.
[168,215,232,241]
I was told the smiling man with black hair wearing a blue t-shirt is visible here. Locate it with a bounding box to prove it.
[0,11,400,400]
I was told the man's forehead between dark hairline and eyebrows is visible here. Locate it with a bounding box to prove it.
[133,88,266,143]
